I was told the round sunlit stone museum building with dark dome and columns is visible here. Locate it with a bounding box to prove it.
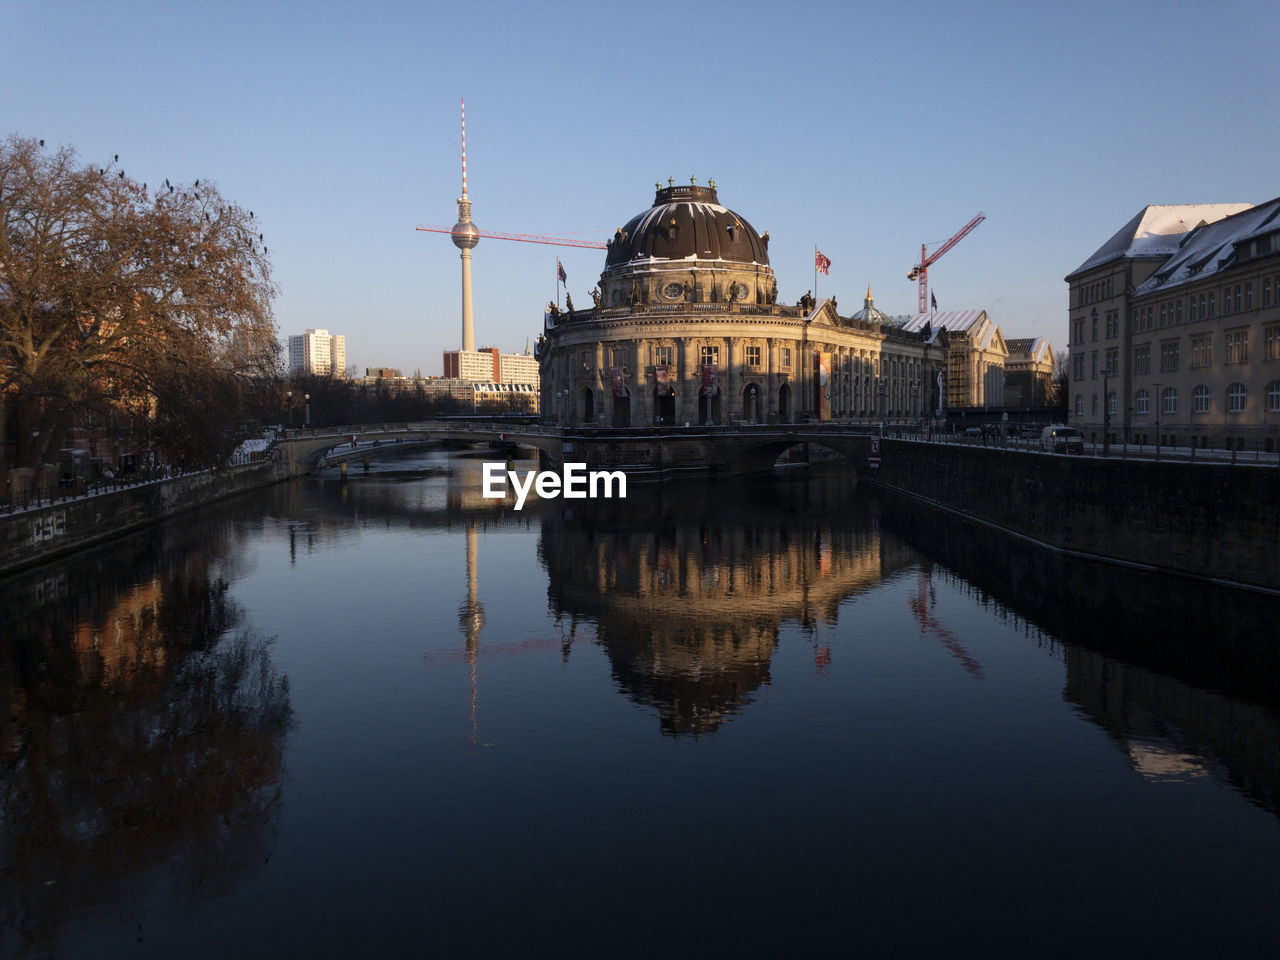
[536,180,946,426]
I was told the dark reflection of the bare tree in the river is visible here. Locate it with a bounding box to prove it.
[0,545,291,956]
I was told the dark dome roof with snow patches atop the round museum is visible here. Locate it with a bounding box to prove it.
[604,180,769,269]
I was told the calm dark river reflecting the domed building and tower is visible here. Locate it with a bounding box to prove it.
[0,452,1280,959]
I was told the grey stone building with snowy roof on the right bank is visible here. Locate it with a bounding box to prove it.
[1066,198,1280,451]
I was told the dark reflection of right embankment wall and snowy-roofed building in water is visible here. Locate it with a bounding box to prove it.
[881,497,1280,815]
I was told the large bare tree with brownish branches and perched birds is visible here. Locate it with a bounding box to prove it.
[0,137,279,466]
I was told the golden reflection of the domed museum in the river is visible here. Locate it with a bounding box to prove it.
[539,479,915,737]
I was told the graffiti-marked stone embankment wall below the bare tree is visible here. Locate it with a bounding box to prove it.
[0,461,285,573]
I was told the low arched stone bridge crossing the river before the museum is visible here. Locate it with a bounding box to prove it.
[276,420,874,479]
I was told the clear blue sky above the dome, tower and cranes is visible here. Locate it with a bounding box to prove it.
[0,0,1280,374]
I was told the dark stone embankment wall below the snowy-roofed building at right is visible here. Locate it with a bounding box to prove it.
[867,440,1280,590]
